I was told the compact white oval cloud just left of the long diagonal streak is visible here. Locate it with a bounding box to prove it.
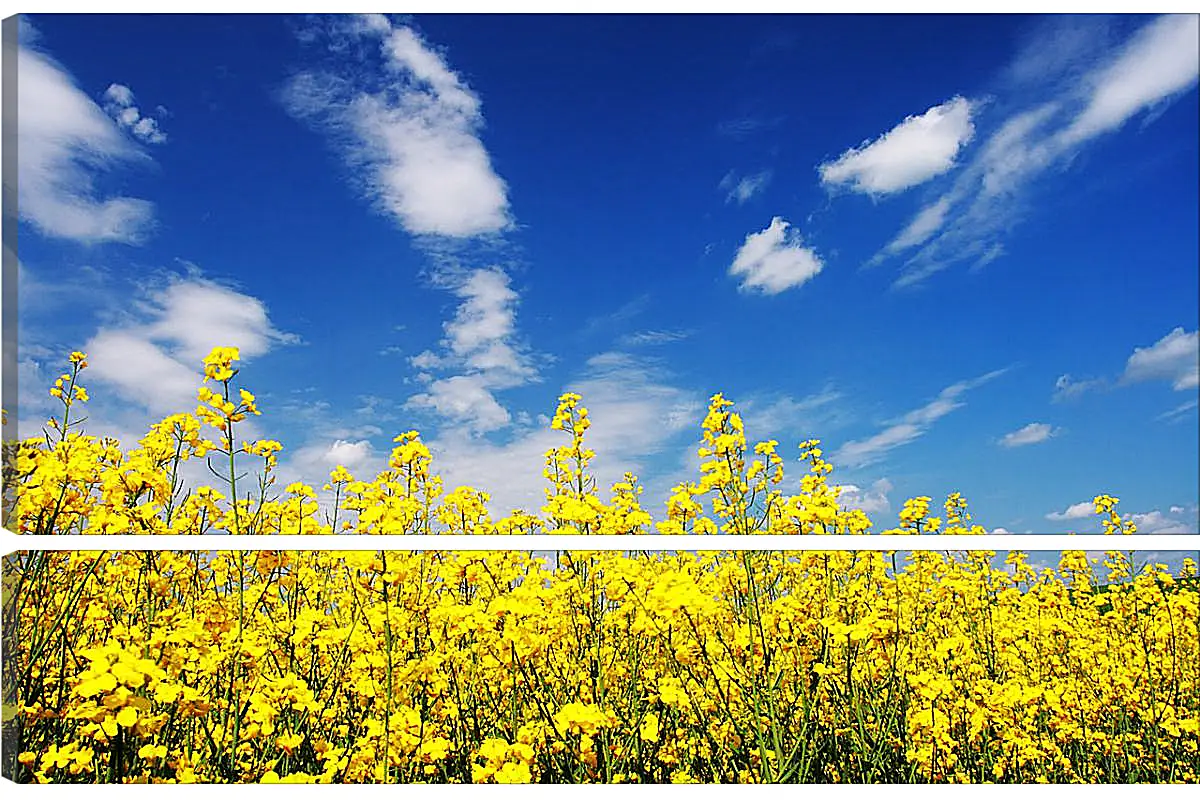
[817,97,974,196]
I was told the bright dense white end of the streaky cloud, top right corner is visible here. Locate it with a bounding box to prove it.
[1060,14,1200,145]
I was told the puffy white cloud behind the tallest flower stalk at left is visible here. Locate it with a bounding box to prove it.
[83,278,296,414]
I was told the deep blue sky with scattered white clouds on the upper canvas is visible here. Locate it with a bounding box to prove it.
[5,14,1200,533]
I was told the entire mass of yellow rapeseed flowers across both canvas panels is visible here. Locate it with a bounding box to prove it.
[4,348,1200,783]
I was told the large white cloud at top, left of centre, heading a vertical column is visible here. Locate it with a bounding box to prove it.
[283,16,511,237]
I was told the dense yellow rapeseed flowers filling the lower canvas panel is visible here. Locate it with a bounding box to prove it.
[4,551,1200,783]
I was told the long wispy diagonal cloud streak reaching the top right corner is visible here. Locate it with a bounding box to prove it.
[869,14,1200,287]
